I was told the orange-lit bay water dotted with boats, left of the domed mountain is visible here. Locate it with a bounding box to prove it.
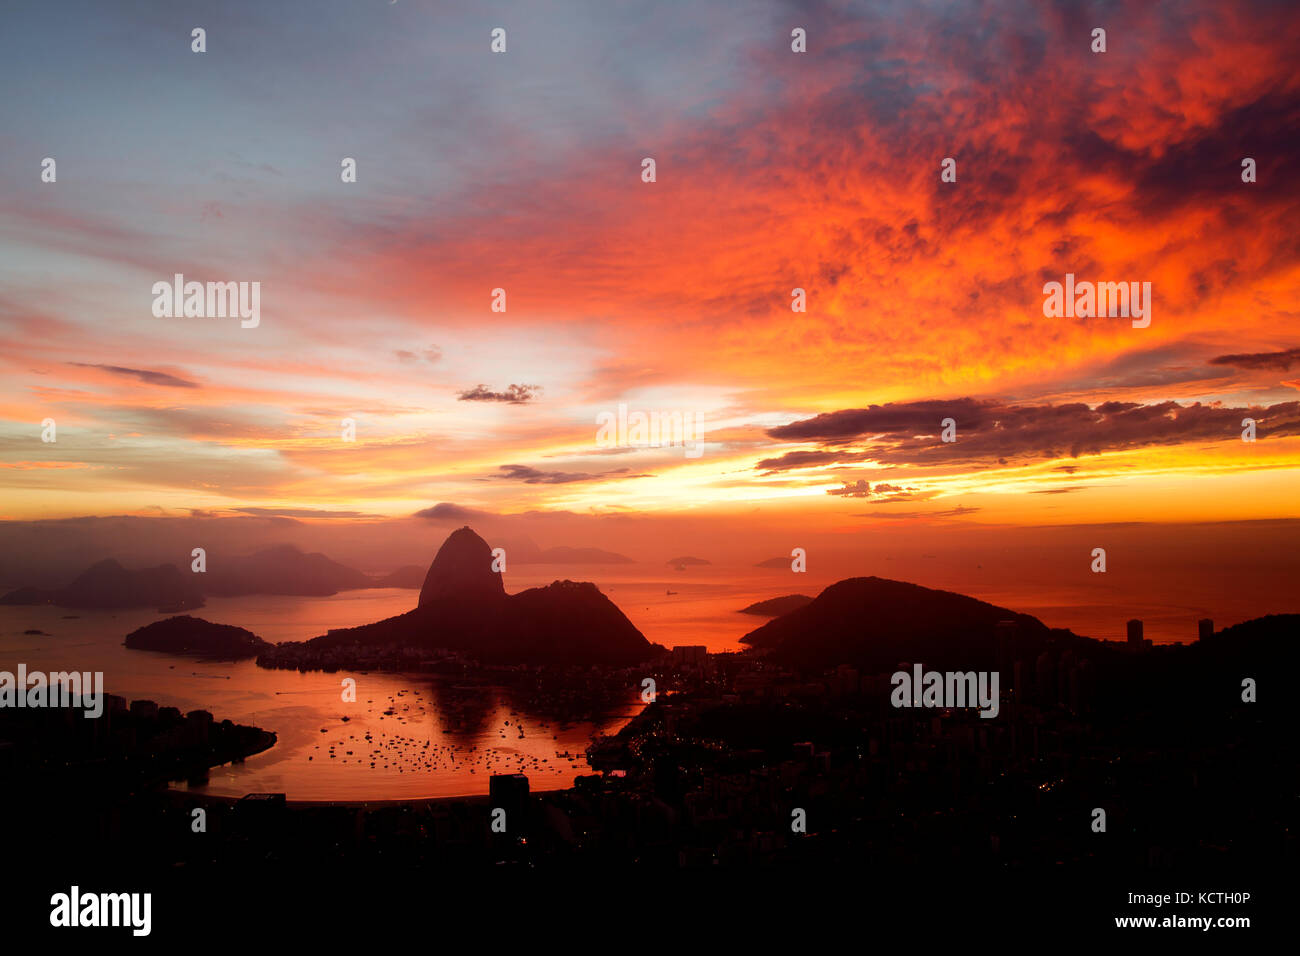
[0,589,660,800]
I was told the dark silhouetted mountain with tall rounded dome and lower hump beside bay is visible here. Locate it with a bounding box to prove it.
[277,527,663,665]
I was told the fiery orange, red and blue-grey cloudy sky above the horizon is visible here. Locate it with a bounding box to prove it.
[0,0,1300,538]
